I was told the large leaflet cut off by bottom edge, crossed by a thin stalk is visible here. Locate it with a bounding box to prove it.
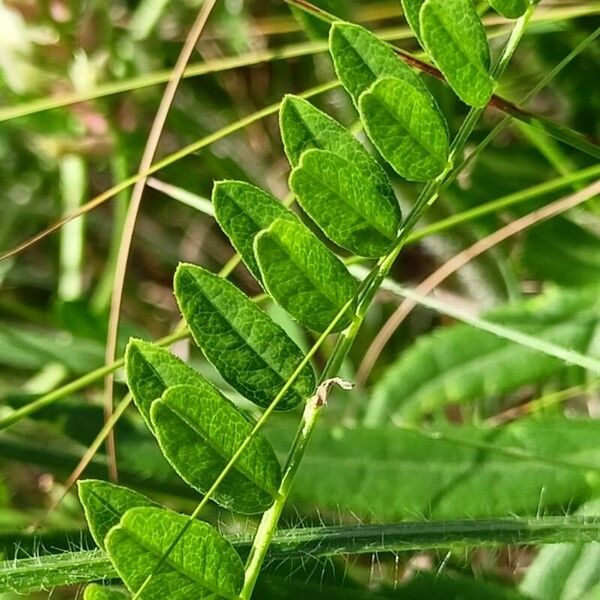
[106,508,244,600]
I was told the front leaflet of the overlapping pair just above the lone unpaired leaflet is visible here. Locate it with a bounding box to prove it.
[254,219,357,332]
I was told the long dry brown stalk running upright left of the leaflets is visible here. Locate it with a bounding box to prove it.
[104,0,217,481]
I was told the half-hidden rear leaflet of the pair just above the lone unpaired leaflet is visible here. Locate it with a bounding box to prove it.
[212,181,296,281]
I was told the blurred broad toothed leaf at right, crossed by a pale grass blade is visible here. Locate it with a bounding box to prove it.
[366,287,600,425]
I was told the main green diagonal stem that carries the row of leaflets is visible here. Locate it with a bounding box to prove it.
[240,10,534,600]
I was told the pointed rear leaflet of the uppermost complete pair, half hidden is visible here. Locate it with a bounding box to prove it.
[329,23,426,106]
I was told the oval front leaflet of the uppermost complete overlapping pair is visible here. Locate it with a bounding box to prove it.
[359,78,449,181]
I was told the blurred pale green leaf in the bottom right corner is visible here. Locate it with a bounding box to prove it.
[519,500,600,600]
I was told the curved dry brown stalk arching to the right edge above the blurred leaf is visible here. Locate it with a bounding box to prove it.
[356,180,600,386]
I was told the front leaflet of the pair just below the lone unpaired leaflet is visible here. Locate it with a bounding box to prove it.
[151,383,281,514]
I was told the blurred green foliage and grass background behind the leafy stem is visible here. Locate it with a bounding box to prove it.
[0,0,600,600]
